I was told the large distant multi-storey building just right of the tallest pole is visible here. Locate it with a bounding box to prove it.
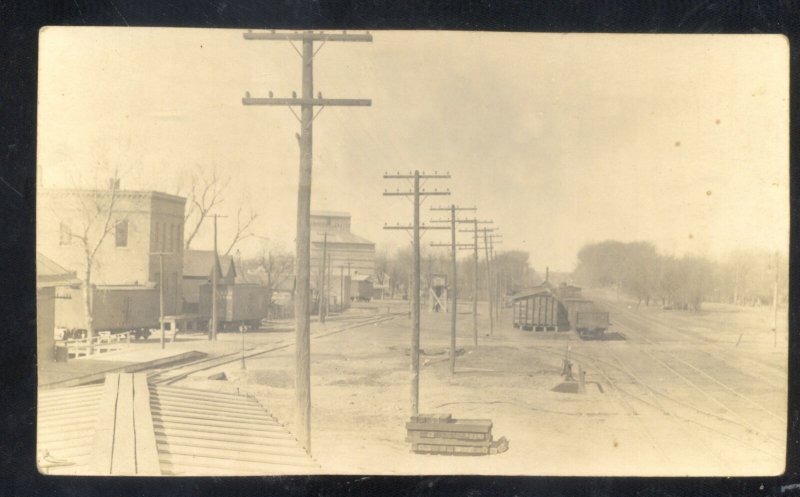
[311,211,375,302]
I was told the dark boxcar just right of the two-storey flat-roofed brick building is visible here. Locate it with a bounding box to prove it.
[200,283,270,331]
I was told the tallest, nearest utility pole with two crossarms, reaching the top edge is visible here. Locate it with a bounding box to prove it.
[242,31,372,454]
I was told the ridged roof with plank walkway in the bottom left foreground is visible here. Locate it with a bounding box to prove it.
[36,373,319,476]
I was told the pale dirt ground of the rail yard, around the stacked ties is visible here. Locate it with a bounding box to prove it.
[173,292,788,475]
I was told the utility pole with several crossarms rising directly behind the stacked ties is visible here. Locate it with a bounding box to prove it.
[383,171,450,416]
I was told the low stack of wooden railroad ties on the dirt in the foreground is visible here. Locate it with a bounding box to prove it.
[406,414,508,455]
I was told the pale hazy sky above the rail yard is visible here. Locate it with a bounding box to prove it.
[38,28,789,270]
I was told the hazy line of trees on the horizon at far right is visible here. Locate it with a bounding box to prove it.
[573,240,788,310]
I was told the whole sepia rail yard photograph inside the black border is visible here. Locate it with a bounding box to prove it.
[36,26,790,476]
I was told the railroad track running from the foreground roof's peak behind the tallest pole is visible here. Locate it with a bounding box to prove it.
[147,312,400,385]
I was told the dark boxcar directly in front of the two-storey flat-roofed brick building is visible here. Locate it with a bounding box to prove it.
[55,286,160,337]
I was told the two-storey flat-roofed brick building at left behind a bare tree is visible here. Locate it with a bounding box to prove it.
[36,184,186,314]
